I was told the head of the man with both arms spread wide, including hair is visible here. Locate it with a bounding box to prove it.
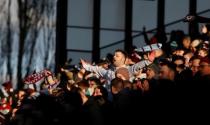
[113,49,127,67]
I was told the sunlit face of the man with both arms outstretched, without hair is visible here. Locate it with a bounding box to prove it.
[113,52,125,67]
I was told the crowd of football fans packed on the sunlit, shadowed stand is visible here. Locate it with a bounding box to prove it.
[0,24,210,125]
